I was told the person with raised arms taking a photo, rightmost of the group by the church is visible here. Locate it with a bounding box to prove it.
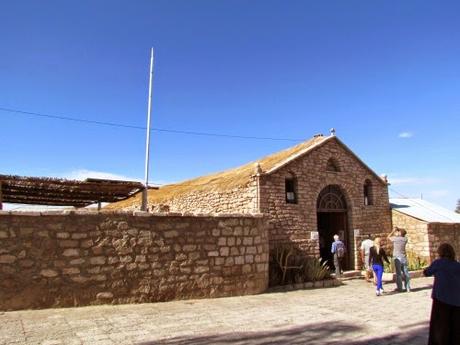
[388,227,410,292]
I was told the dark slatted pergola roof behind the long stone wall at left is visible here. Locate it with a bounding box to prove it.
[0,175,149,210]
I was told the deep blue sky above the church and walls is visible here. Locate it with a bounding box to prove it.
[0,0,460,209]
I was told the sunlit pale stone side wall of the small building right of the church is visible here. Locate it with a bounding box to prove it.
[392,210,432,262]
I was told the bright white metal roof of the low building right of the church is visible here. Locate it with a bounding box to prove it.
[390,199,460,223]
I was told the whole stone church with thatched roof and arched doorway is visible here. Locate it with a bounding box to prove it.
[109,133,391,270]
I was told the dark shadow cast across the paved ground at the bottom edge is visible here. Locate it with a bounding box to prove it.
[138,322,428,345]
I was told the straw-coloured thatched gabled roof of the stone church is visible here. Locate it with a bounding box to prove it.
[108,135,385,208]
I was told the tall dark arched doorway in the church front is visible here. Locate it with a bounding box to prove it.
[316,185,352,270]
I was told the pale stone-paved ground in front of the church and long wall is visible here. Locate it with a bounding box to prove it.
[0,278,432,345]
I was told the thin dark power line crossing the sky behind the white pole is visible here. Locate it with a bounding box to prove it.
[0,107,305,142]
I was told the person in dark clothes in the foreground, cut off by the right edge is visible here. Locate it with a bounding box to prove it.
[423,243,460,345]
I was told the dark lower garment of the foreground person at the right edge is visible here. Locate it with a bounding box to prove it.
[428,298,460,345]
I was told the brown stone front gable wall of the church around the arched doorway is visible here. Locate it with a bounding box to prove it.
[260,141,391,268]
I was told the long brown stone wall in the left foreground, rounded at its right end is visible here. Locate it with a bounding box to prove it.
[0,211,268,310]
